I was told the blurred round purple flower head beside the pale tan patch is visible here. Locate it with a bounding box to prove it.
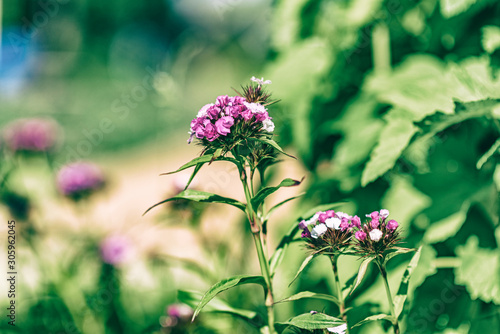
[57,162,104,196]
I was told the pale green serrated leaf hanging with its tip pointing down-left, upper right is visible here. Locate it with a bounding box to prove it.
[361,109,417,187]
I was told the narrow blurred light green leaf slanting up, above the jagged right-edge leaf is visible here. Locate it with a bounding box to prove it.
[424,203,470,244]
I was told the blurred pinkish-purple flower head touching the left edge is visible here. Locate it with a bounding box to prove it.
[3,118,59,152]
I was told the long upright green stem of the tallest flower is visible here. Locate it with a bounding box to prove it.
[241,164,276,334]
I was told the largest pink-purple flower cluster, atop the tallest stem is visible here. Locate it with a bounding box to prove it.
[188,95,274,142]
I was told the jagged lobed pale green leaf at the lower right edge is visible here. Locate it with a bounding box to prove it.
[455,236,500,305]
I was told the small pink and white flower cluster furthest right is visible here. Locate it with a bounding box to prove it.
[354,209,399,242]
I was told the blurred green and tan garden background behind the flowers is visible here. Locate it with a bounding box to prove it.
[0,0,500,334]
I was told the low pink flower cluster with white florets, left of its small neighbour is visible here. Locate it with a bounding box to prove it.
[299,210,361,239]
